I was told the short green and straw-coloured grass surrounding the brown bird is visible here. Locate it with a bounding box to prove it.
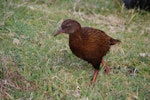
[0,0,150,100]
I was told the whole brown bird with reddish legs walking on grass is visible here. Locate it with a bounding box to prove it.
[54,19,121,86]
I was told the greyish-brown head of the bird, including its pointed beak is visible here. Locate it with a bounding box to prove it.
[54,19,81,36]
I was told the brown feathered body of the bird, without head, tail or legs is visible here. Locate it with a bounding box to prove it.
[69,27,118,69]
